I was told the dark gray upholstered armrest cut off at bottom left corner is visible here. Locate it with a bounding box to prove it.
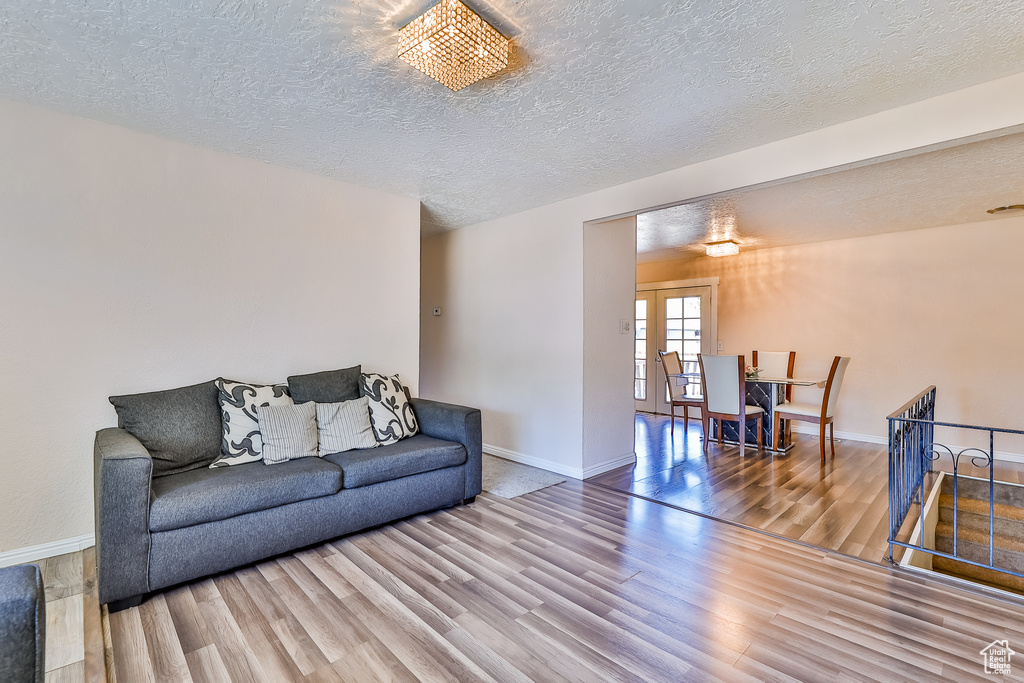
[0,564,46,683]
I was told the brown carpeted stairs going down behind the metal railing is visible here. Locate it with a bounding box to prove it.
[932,476,1024,593]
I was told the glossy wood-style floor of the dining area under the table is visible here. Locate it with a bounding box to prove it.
[588,413,1024,562]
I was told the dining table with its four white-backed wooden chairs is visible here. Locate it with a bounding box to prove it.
[657,349,850,463]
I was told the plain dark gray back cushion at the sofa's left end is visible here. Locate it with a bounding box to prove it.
[110,381,221,477]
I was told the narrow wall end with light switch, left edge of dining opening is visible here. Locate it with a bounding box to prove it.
[579,216,637,478]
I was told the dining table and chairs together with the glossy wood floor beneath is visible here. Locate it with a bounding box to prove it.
[587,340,888,561]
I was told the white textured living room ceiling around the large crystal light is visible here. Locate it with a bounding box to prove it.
[0,0,1024,232]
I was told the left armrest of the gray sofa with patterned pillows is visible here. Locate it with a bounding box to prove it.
[93,428,153,603]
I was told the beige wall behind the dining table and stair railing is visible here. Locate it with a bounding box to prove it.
[637,217,1024,451]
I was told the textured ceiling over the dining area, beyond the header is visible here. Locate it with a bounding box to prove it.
[637,133,1024,263]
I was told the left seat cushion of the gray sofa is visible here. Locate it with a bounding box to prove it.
[150,458,341,531]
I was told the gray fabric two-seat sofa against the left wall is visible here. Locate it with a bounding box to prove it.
[94,376,482,610]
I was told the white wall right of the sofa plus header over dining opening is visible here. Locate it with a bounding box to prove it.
[421,69,1024,473]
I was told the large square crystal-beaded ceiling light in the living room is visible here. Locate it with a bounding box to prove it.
[398,0,509,92]
